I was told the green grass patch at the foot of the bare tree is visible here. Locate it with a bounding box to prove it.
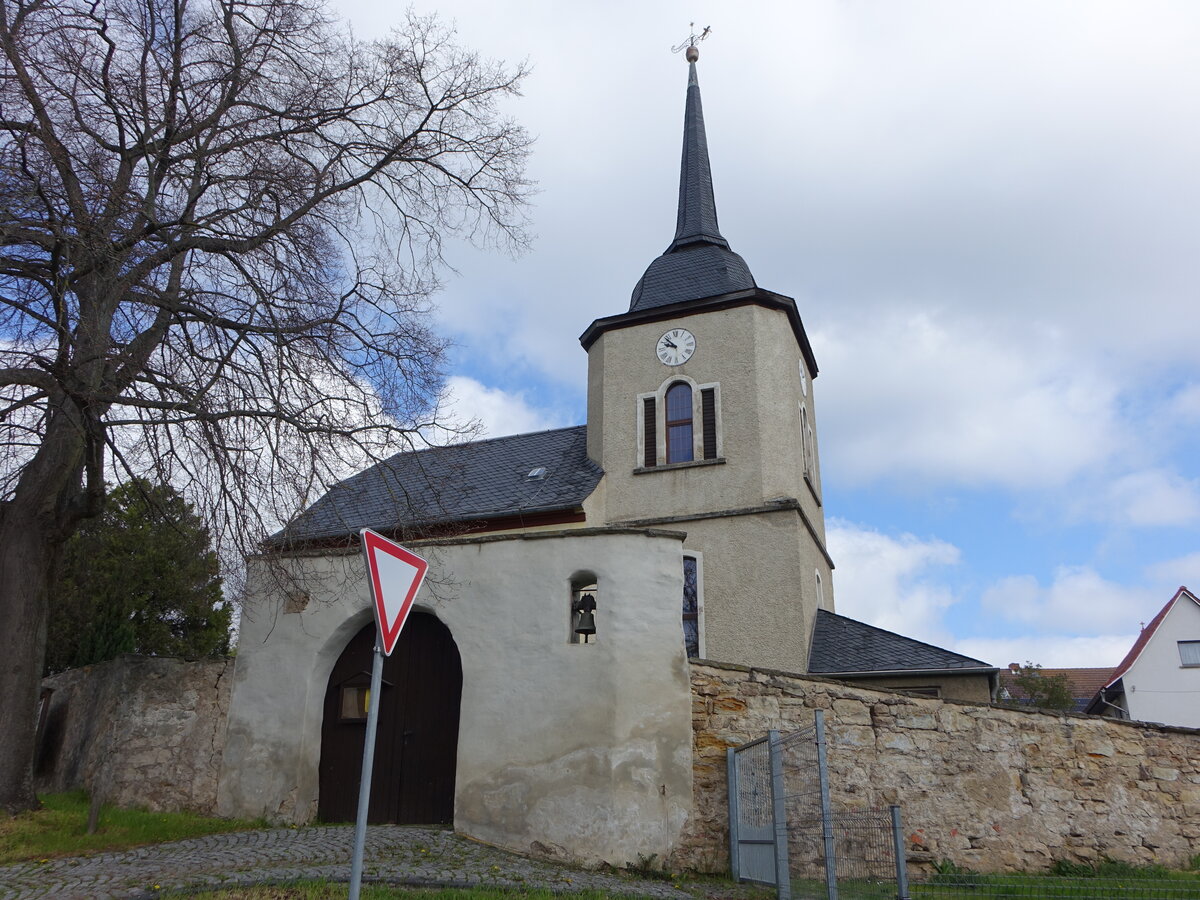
[0,791,265,865]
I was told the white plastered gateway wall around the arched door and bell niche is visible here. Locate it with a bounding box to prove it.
[218,529,692,864]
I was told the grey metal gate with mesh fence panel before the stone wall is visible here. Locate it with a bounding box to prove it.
[727,709,907,900]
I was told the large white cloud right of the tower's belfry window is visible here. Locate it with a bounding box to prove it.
[817,312,1122,490]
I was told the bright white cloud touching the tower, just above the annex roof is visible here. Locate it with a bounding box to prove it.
[826,520,960,646]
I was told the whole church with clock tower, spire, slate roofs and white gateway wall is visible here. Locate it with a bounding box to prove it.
[218,47,996,865]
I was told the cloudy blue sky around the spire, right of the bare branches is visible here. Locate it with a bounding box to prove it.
[336,0,1200,667]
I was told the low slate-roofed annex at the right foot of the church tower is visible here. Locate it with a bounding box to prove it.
[809,610,1000,703]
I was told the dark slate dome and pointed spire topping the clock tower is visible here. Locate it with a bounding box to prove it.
[629,53,755,312]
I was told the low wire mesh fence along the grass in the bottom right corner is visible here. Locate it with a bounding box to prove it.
[910,872,1200,900]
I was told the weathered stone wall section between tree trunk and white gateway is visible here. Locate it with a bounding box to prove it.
[34,656,234,815]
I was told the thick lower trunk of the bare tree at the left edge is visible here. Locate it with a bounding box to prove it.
[0,505,54,814]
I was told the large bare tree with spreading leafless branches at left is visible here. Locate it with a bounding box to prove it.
[0,0,529,811]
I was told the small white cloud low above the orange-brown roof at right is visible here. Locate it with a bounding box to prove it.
[980,566,1165,638]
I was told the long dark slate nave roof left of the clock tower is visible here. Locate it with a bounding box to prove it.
[272,425,604,544]
